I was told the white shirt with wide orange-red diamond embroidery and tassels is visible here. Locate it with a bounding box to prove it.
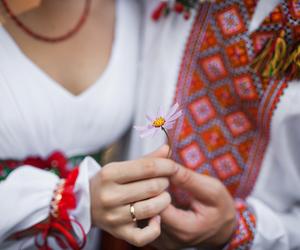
[131,0,300,250]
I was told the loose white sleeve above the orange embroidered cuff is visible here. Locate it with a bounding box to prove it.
[247,82,300,250]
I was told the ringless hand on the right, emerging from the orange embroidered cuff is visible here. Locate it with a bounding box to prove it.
[154,167,237,250]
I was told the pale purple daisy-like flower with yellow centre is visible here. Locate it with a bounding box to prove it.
[134,103,182,153]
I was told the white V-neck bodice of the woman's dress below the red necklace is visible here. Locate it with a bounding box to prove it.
[0,1,139,159]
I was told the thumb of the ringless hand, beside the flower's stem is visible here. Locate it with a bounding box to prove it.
[170,166,222,203]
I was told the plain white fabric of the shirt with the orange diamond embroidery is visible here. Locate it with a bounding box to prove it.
[130,0,300,250]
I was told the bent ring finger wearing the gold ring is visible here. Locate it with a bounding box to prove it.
[110,192,171,225]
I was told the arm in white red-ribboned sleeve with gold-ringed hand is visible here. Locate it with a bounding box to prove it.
[0,147,177,246]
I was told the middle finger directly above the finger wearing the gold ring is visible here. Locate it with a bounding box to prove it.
[116,178,169,205]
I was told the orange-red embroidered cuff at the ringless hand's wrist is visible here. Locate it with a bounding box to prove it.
[223,199,256,250]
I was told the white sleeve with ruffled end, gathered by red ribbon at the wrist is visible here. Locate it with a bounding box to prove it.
[0,157,100,246]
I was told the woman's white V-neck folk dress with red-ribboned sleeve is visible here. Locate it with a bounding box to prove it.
[0,0,140,250]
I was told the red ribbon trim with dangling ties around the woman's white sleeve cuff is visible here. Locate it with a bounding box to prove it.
[14,168,86,250]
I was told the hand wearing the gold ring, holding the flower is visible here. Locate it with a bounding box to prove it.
[90,146,178,246]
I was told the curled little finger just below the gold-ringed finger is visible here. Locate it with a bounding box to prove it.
[121,216,161,247]
